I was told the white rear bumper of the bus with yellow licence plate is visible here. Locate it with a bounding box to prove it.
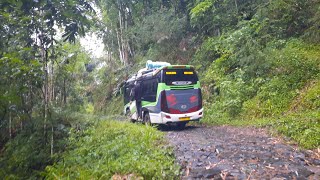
[150,108,203,124]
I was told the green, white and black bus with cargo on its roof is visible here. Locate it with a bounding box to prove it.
[124,64,203,127]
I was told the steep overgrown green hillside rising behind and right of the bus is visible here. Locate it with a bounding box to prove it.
[98,0,320,148]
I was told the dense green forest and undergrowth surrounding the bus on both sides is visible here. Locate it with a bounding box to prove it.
[0,0,320,179]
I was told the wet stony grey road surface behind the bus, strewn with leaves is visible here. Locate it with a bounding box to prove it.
[164,126,320,180]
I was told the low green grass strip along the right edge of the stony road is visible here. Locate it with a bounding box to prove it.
[202,111,320,149]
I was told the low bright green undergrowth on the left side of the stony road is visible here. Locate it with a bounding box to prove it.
[46,121,179,179]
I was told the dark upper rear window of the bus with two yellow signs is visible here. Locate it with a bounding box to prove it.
[163,69,198,85]
